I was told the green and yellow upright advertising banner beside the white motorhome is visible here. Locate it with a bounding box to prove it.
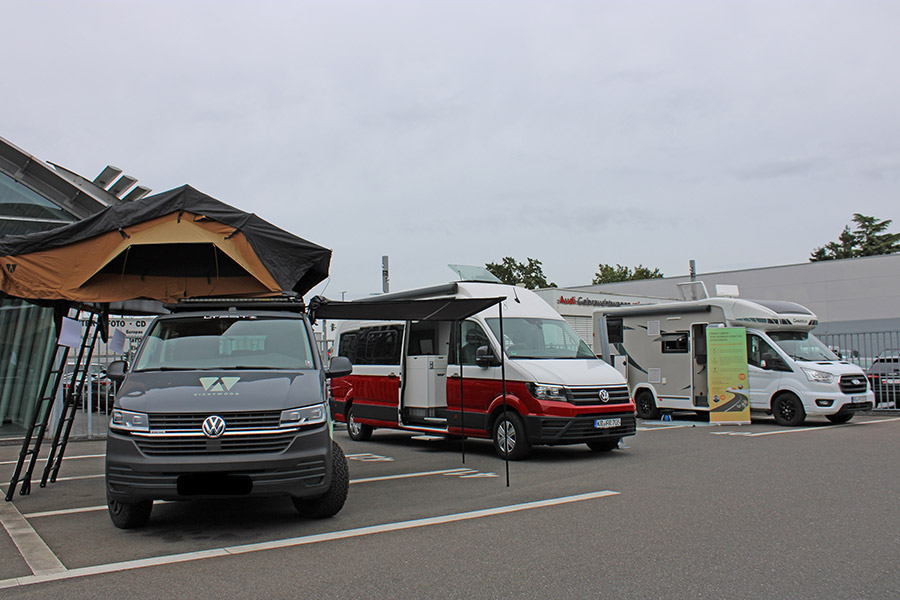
[706,327,750,425]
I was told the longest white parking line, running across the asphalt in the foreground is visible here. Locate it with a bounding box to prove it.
[0,490,619,589]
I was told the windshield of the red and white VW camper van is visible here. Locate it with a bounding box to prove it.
[485,317,599,360]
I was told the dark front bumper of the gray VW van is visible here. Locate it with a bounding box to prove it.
[106,426,332,502]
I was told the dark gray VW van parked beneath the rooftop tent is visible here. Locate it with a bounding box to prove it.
[106,299,352,529]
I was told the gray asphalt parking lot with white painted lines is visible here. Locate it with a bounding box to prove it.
[0,415,900,598]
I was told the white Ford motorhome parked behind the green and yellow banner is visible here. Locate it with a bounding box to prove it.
[594,298,874,426]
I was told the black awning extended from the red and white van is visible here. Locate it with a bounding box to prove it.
[309,296,506,321]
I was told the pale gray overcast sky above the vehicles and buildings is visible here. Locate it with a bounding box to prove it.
[0,0,900,298]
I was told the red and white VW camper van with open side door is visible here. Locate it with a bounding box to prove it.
[330,282,635,460]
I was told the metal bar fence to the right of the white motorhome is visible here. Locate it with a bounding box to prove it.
[818,331,900,410]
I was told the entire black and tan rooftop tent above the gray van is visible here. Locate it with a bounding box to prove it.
[0,185,331,302]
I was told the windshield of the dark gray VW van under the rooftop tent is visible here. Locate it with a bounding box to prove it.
[134,315,314,371]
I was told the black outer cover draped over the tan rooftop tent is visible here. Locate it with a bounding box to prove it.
[0,185,331,295]
